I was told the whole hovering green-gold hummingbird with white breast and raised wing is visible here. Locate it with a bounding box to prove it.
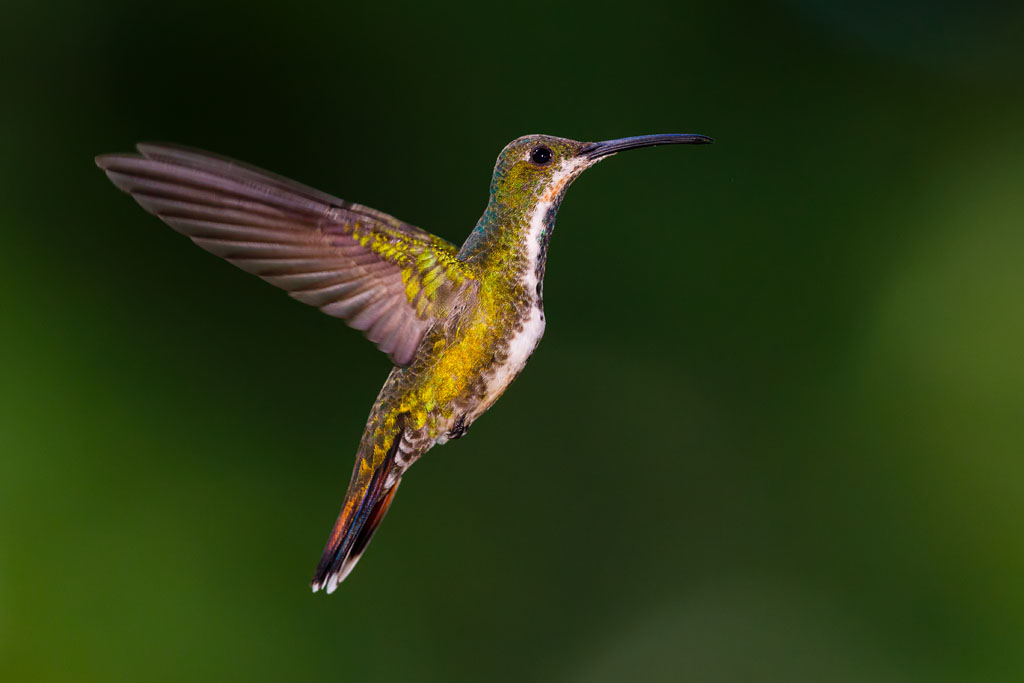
[96,134,713,593]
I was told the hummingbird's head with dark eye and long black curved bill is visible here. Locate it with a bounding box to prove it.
[490,134,712,213]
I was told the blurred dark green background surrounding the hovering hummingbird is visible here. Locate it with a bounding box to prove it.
[0,0,1024,683]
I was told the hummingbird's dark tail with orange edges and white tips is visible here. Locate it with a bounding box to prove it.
[312,417,409,593]
